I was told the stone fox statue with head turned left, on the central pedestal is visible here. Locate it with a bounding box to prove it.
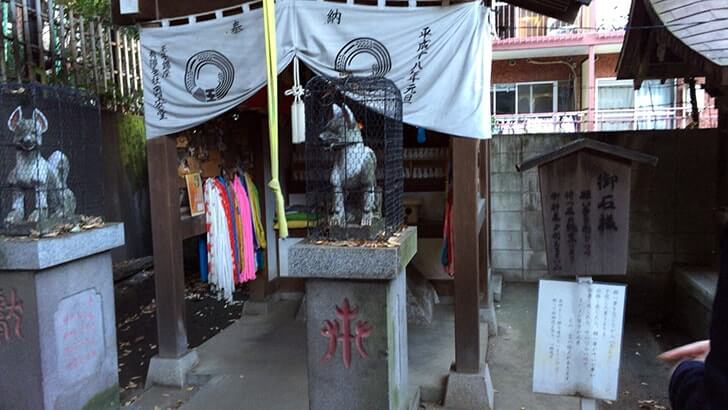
[319,104,377,226]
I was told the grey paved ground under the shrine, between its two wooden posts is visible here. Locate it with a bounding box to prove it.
[127,300,488,410]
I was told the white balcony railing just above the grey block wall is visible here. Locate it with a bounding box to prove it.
[493,107,718,135]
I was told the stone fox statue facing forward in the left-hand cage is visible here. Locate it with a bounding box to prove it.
[5,107,76,225]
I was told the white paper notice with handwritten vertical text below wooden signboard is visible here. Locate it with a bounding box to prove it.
[533,280,626,400]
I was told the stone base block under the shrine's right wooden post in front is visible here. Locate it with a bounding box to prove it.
[444,364,493,410]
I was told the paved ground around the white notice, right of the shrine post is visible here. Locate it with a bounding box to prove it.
[489,283,686,410]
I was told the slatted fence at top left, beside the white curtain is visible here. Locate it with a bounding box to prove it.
[0,0,142,109]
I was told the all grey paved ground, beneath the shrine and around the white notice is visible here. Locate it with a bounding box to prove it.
[125,283,689,410]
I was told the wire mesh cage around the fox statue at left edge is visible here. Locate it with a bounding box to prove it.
[0,84,103,236]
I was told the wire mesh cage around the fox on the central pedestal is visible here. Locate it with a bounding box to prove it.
[304,76,404,241]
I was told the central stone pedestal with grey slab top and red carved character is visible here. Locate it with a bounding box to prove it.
[288,228,417,410]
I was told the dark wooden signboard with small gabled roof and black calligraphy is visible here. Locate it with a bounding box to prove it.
[518,139,657,276]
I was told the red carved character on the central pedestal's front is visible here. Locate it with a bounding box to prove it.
[321,298,374,369]
